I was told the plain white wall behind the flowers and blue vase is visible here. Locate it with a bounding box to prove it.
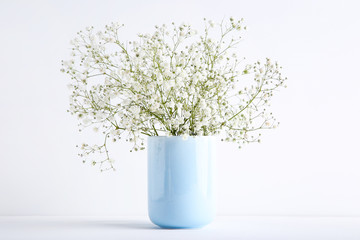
[0,0,360,215]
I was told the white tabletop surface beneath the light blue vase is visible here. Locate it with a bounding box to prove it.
[0,216,360,240]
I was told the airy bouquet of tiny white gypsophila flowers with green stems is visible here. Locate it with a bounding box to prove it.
[61,18,286,171]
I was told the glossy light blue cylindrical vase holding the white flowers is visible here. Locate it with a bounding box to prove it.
[148,136,216,228]
